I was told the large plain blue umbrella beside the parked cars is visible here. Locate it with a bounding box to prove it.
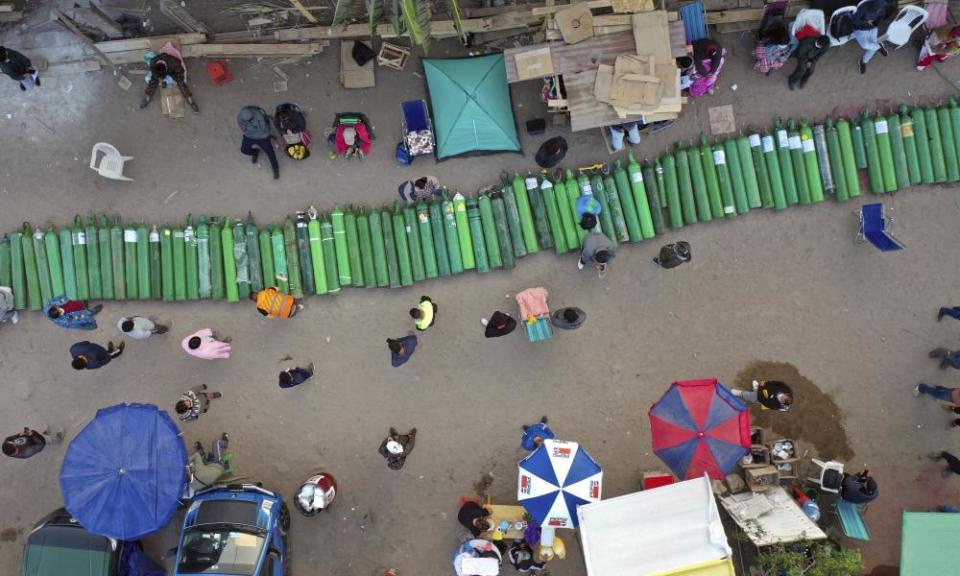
[60,404,187,540]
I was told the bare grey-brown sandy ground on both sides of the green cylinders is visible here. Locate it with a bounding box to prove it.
[0,16,960,576]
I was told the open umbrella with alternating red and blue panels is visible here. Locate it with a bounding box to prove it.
[648,380,750,480]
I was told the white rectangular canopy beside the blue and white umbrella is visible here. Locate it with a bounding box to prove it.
[577,476,731,576]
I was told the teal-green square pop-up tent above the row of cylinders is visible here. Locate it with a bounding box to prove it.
[422,54,520,160]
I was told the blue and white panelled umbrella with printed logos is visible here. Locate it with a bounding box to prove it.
[517,440,603,528]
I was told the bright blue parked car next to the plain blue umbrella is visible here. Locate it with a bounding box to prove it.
[175,484,290,576]
